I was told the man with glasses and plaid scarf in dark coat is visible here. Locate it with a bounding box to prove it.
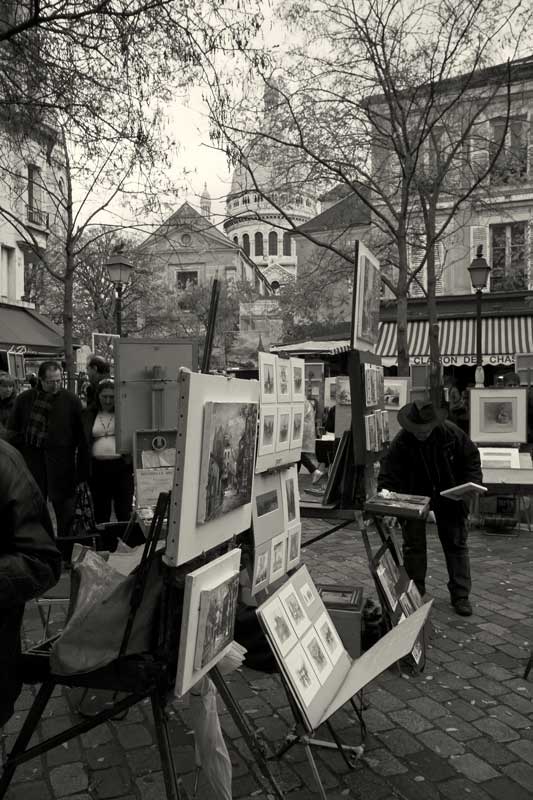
[7,361,87,536]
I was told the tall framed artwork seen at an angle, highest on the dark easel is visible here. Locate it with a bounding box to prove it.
[351,242,381,353]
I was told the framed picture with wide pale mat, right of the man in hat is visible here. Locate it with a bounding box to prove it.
[470,386,527,444]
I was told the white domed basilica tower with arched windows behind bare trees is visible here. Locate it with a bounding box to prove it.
[224,90,317,291]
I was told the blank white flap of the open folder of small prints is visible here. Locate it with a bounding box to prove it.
[316,600,433,727]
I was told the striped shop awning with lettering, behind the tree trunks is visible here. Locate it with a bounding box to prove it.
[376,316,533,366]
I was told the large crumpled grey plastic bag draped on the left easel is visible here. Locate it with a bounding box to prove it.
[50,548,162,675]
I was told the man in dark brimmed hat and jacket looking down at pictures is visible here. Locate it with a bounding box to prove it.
[378,401,483,616]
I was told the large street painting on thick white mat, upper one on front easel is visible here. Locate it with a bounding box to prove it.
[165,370,259,566]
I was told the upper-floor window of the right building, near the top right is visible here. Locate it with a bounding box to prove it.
[490,119,528,185]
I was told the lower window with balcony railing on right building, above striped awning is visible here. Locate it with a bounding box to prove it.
[490,222,527,292]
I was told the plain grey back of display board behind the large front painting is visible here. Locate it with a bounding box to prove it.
[115,338,198,453]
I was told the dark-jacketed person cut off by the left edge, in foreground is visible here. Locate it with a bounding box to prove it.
[0,441,61,727]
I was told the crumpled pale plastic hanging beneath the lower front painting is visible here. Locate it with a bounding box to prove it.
[191,678,232,800]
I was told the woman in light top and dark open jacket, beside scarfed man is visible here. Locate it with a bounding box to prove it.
[82,378,133,524]
